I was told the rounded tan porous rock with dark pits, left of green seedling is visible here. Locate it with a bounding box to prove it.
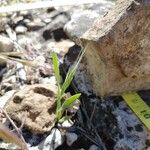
[5,84,57,134]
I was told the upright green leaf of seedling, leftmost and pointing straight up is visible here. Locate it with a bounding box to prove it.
[52,52,60,85]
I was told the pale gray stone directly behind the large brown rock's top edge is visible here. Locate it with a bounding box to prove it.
[64,0,114,44]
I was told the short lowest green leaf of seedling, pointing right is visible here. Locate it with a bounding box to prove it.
[62,93,81,110]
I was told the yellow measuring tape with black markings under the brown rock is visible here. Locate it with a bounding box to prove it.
[122,92,150,130]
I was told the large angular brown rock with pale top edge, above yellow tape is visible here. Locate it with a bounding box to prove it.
[81,0,150,96]
